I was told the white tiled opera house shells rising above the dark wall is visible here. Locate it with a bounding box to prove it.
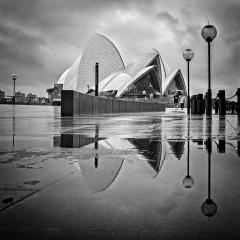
[57,34,186,98]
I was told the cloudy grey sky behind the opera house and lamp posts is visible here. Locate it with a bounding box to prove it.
[0,0,240,96]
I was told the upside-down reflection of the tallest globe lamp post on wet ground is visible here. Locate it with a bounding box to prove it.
[201,138,217,217]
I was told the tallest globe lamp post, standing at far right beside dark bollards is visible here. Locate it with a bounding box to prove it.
[201,24,217,116]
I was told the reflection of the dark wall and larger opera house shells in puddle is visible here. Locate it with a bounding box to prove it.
[53,132,164,193]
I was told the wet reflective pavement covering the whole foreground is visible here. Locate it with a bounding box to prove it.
[0,105,240,239]
